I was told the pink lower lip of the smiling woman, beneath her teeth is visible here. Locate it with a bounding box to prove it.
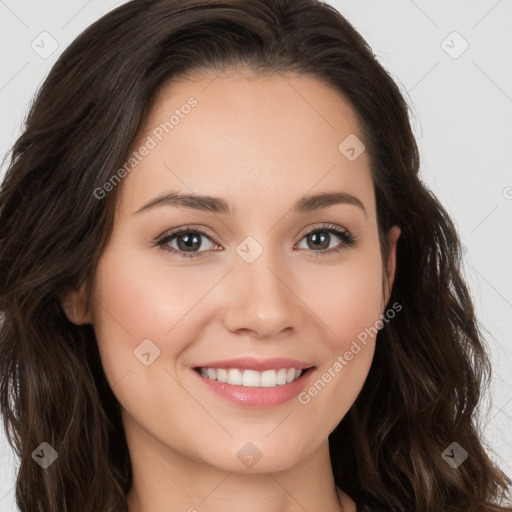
[192,367,314,408]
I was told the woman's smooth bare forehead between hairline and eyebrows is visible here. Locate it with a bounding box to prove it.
[121,68,373,220]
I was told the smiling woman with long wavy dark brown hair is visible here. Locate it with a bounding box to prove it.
[0,0,512,512]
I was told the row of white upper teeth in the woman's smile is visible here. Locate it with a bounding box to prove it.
[200,368,303,388]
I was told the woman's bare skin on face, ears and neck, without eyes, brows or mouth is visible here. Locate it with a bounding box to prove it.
[64,71,400,512]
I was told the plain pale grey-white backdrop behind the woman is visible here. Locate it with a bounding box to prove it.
[0,0,512,512]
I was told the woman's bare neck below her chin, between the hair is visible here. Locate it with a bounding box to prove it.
[125,412,355,512]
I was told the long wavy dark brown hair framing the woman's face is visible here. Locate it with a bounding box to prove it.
[0,0,512,512]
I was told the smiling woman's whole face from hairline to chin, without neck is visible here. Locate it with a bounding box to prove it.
[68,73,399,472]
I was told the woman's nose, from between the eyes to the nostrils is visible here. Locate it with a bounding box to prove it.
[224,242,306,338]
